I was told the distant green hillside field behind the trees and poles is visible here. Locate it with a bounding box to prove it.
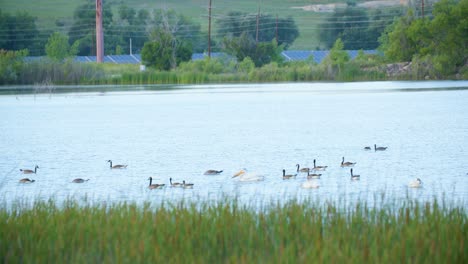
[0,0,400,49]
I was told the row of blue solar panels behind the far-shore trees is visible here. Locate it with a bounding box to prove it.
[25,50,377,64]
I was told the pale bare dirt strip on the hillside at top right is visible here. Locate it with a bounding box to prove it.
[291,0,408,13]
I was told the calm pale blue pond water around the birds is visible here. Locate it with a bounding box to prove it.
[0,81,468,207]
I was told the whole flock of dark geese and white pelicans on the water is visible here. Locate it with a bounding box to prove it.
[19,144,422,189]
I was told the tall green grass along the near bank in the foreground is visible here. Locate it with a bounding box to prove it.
[0,201,468,263]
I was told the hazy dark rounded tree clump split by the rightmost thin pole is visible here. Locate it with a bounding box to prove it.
[217,11,299,49]
